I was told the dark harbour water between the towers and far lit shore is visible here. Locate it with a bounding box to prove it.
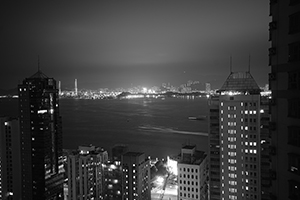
[0,98,208,157]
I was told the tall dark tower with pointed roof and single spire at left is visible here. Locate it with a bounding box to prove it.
[18,70,63,200]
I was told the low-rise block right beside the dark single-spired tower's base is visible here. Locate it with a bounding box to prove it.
[67,146,108,200]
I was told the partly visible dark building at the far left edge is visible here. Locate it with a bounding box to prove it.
[0,117,22,200]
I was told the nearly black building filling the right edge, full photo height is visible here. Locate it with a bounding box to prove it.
[269,0,300,199]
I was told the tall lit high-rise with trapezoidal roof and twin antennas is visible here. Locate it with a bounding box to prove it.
[209,72,261,200]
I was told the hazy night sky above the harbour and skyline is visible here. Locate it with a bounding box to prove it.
[0,0,270,89]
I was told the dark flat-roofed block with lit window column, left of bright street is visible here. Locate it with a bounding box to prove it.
[121,152,151,200]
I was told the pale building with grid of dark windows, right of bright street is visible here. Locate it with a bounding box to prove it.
[177,145,208,200]
